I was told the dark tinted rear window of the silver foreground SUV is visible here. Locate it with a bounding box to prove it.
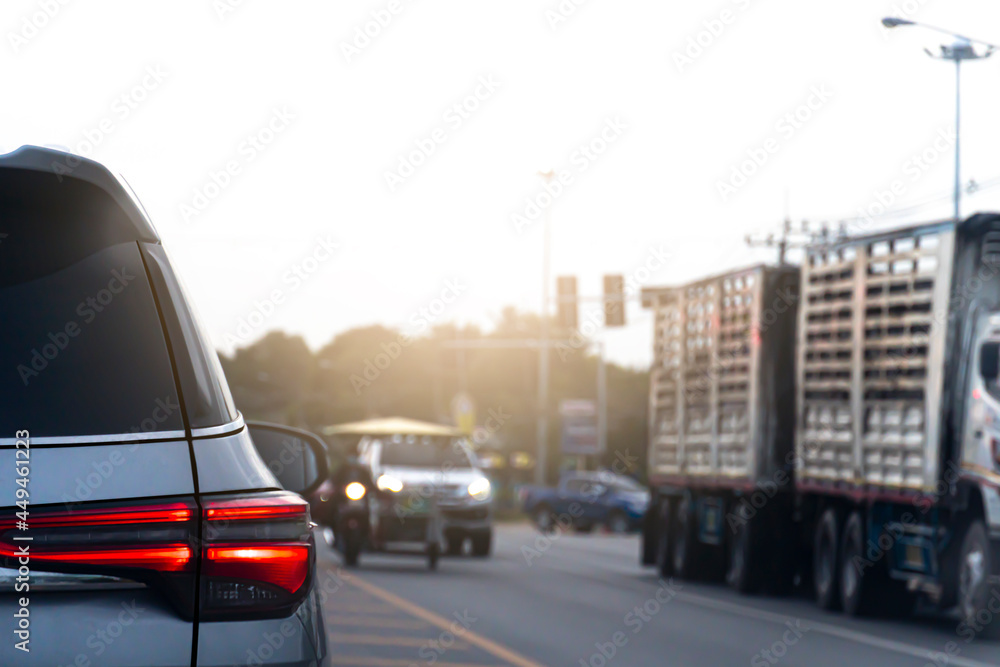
[0,170,184,438]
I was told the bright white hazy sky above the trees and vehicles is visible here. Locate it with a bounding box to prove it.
[7,0,1000,365]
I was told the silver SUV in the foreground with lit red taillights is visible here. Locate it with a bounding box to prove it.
[0,147,327,667]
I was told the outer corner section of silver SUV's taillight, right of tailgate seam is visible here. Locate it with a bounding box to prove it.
[201,492,316,620]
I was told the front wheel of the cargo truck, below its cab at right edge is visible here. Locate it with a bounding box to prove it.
[958,519,1000,639]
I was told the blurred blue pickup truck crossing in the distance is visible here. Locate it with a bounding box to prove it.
[520,472,649,533]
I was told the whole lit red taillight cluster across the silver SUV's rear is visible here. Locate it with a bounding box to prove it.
[0,491,316,620]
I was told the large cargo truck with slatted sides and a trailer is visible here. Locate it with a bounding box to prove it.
[642,214,1000,636]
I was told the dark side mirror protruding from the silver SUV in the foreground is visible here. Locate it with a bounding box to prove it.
[247,422,328,496]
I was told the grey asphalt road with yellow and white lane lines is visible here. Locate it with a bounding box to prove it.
[320,525,1000,667]
